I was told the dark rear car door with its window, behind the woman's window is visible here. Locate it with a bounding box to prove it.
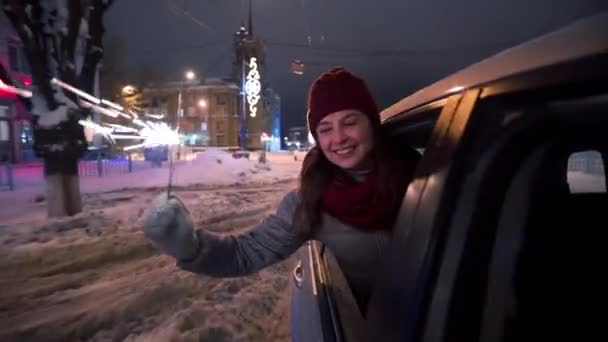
[420,88,608,341]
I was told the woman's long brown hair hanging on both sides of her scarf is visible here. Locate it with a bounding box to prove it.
[293,126,419,237]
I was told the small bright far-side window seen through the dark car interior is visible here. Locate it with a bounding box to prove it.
[568,150,606,193]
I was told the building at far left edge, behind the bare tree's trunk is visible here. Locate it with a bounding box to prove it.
[0,13,36,163]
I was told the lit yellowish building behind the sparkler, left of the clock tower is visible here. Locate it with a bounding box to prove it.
[142,78,240,149]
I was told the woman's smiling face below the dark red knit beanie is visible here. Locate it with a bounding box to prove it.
[316,109,374,169]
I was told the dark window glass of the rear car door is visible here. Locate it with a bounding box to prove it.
[481,142,608,341]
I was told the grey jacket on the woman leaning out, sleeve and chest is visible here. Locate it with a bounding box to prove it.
[177,191,389,304]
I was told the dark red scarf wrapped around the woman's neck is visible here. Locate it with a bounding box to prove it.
[321,172,405,231]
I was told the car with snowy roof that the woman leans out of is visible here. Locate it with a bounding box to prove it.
[291,13,608,342]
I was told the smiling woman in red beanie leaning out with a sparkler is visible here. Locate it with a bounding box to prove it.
[144,68,419,313]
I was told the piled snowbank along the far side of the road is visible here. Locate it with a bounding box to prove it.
[0,149,302,227]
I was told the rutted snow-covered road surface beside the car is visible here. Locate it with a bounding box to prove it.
[0,180,296,341]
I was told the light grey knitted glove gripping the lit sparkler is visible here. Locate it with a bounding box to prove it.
[144,193,199,260]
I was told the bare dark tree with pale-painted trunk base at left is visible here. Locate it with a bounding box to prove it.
[2,0,114,217]
